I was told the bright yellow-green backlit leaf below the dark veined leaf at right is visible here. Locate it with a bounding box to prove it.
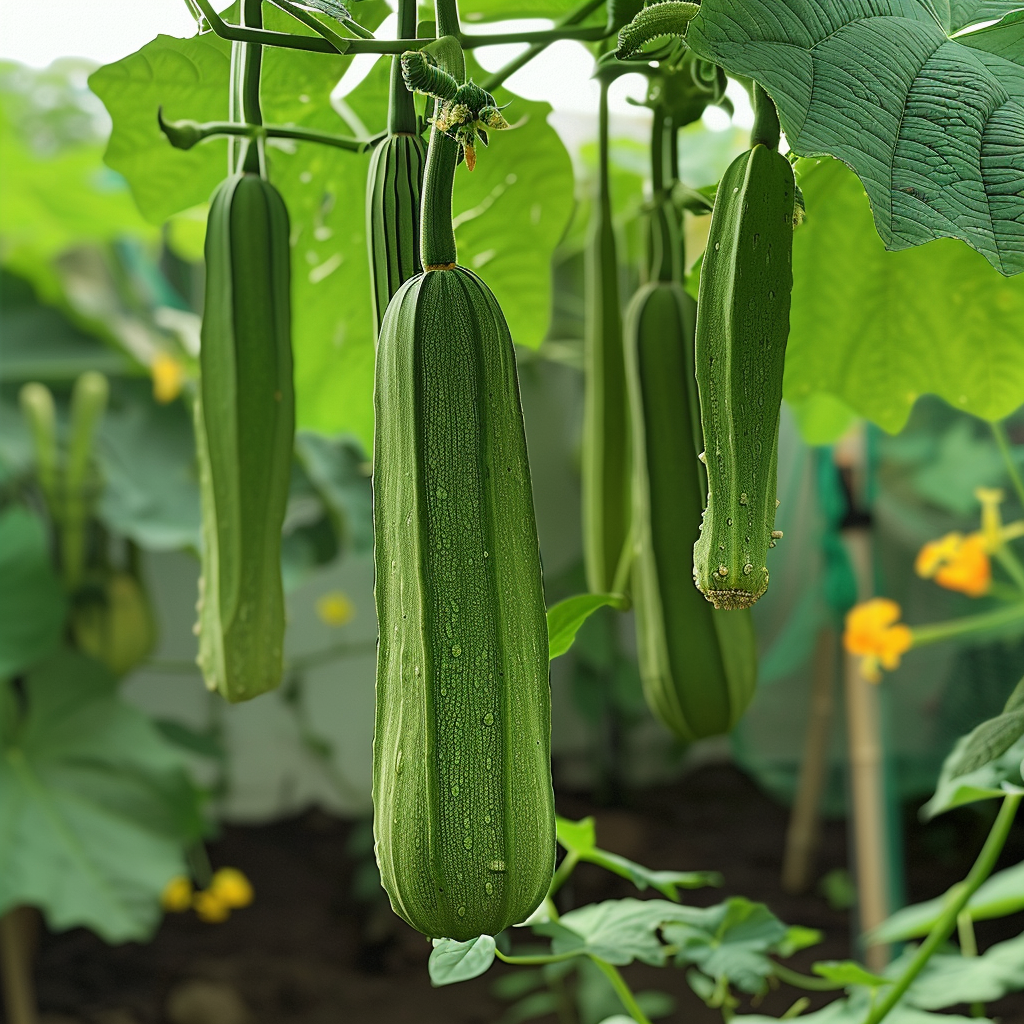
[785,160,1024,443]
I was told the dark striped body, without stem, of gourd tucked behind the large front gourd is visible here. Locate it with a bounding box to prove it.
[367,134,426,331]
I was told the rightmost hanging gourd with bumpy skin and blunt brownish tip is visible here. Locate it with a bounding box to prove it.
[693,145,795,608]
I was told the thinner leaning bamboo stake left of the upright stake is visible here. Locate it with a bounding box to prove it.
[782,626,836,893]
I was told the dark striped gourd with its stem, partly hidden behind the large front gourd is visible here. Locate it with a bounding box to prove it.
[367,0,427,333]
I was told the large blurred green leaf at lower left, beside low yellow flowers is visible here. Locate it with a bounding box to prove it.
[0,651,202,942]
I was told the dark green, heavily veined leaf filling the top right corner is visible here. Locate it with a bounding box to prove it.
[686,0,1024,274]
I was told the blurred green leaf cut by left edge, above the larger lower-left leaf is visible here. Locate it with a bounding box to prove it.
[0,505,67,685]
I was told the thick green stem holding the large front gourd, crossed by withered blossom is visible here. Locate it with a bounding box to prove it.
[420,0,466,270]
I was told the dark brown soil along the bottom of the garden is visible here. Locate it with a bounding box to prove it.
[22,765,1024,1024]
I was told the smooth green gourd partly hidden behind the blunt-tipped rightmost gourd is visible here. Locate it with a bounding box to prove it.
[625,282,757,741]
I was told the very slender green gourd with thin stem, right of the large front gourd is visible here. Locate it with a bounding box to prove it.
[582,80,630,593]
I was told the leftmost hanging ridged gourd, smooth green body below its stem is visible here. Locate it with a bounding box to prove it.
[196,174,295,701]
